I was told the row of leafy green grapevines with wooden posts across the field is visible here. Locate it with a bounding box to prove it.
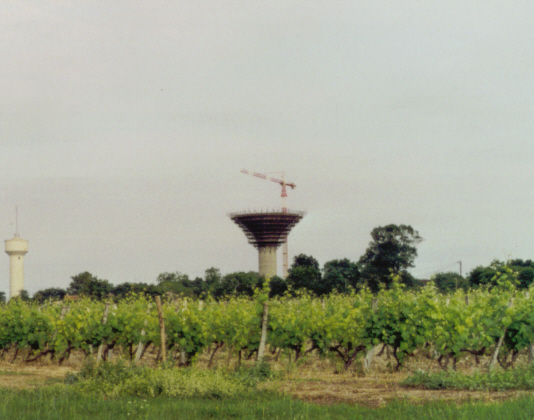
[0,282,534,368]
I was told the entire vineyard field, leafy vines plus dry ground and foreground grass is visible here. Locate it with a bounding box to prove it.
[0,283,534,420]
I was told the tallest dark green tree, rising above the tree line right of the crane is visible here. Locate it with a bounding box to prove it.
[359,224,423,293]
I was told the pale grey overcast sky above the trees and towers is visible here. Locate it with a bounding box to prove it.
[0,0,534,294]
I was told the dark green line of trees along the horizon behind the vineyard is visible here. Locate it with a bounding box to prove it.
[11,224,534,303]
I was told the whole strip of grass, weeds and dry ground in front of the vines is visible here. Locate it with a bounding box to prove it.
[5,357,534,420]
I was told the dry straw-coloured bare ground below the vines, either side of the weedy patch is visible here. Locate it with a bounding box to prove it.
[0,346,534,407]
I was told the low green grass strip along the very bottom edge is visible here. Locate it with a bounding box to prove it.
[0,385,534,420]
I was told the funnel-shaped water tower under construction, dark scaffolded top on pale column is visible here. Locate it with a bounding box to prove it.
[228,209,305,278]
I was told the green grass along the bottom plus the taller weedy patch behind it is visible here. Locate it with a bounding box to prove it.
[0,362,534,420]
